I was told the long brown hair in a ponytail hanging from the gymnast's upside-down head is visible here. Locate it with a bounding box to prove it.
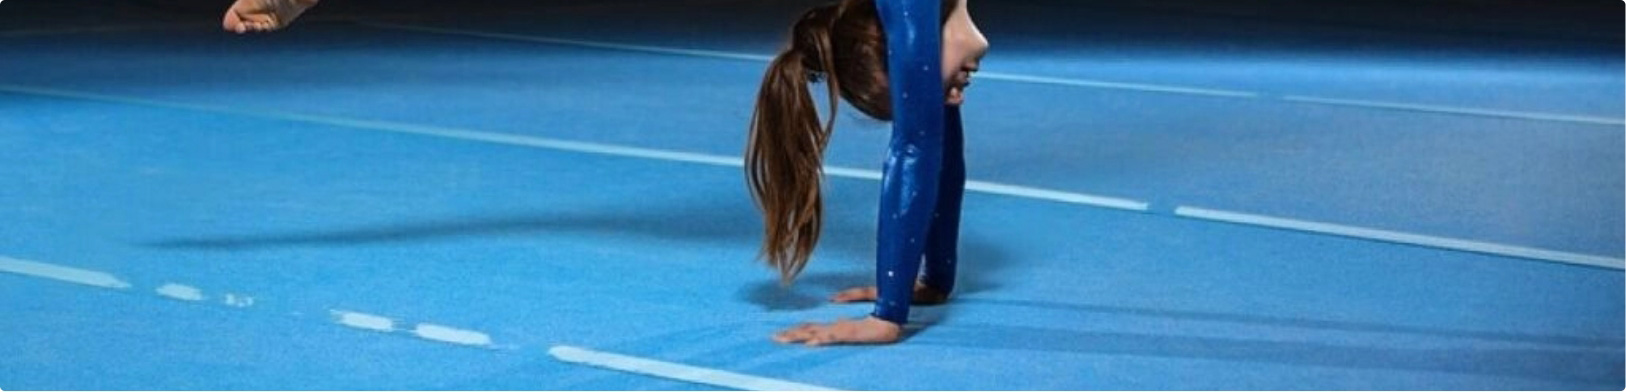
[745,0,956,283]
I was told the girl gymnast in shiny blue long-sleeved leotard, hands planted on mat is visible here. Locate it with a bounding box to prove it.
[745,0,989,345]
